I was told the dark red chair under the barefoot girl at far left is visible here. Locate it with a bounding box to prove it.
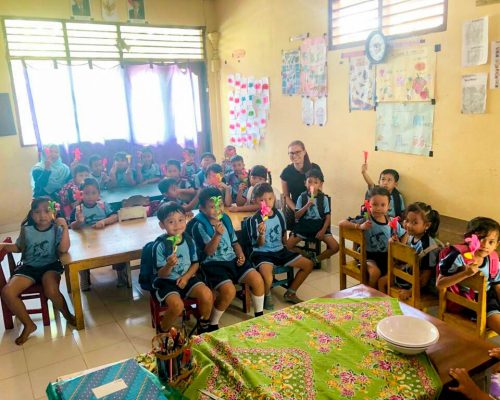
[0,237,50,329]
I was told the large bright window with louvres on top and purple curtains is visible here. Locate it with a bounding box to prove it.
[4,19,209,146]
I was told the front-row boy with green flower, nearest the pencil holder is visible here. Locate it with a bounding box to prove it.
[153,202,213,333]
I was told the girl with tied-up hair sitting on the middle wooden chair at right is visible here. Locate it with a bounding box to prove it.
[379,202,440,300]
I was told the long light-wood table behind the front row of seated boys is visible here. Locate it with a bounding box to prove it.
[61,212,253,330]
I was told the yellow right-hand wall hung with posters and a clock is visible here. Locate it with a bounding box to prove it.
[216,0,500,224]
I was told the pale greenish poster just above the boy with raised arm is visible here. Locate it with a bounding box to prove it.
[375,103,434,156]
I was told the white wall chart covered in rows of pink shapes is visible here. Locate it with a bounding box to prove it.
[227,74,270,147]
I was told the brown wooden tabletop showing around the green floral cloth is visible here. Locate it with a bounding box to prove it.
[325,285,497,399]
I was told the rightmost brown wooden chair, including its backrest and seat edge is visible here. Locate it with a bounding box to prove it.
[438,273,496,338]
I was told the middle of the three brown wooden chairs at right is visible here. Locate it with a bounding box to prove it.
[387,242,438,311]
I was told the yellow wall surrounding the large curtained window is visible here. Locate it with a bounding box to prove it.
[0,0,222,232]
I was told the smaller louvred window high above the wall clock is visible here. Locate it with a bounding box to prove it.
[328,0,448,49]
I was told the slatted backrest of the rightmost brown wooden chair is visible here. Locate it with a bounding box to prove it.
[438,272,487,337]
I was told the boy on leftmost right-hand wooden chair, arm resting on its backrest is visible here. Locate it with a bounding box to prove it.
[339,186,406,290]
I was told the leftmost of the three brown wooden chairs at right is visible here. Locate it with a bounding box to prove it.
[339,226,368,290]
